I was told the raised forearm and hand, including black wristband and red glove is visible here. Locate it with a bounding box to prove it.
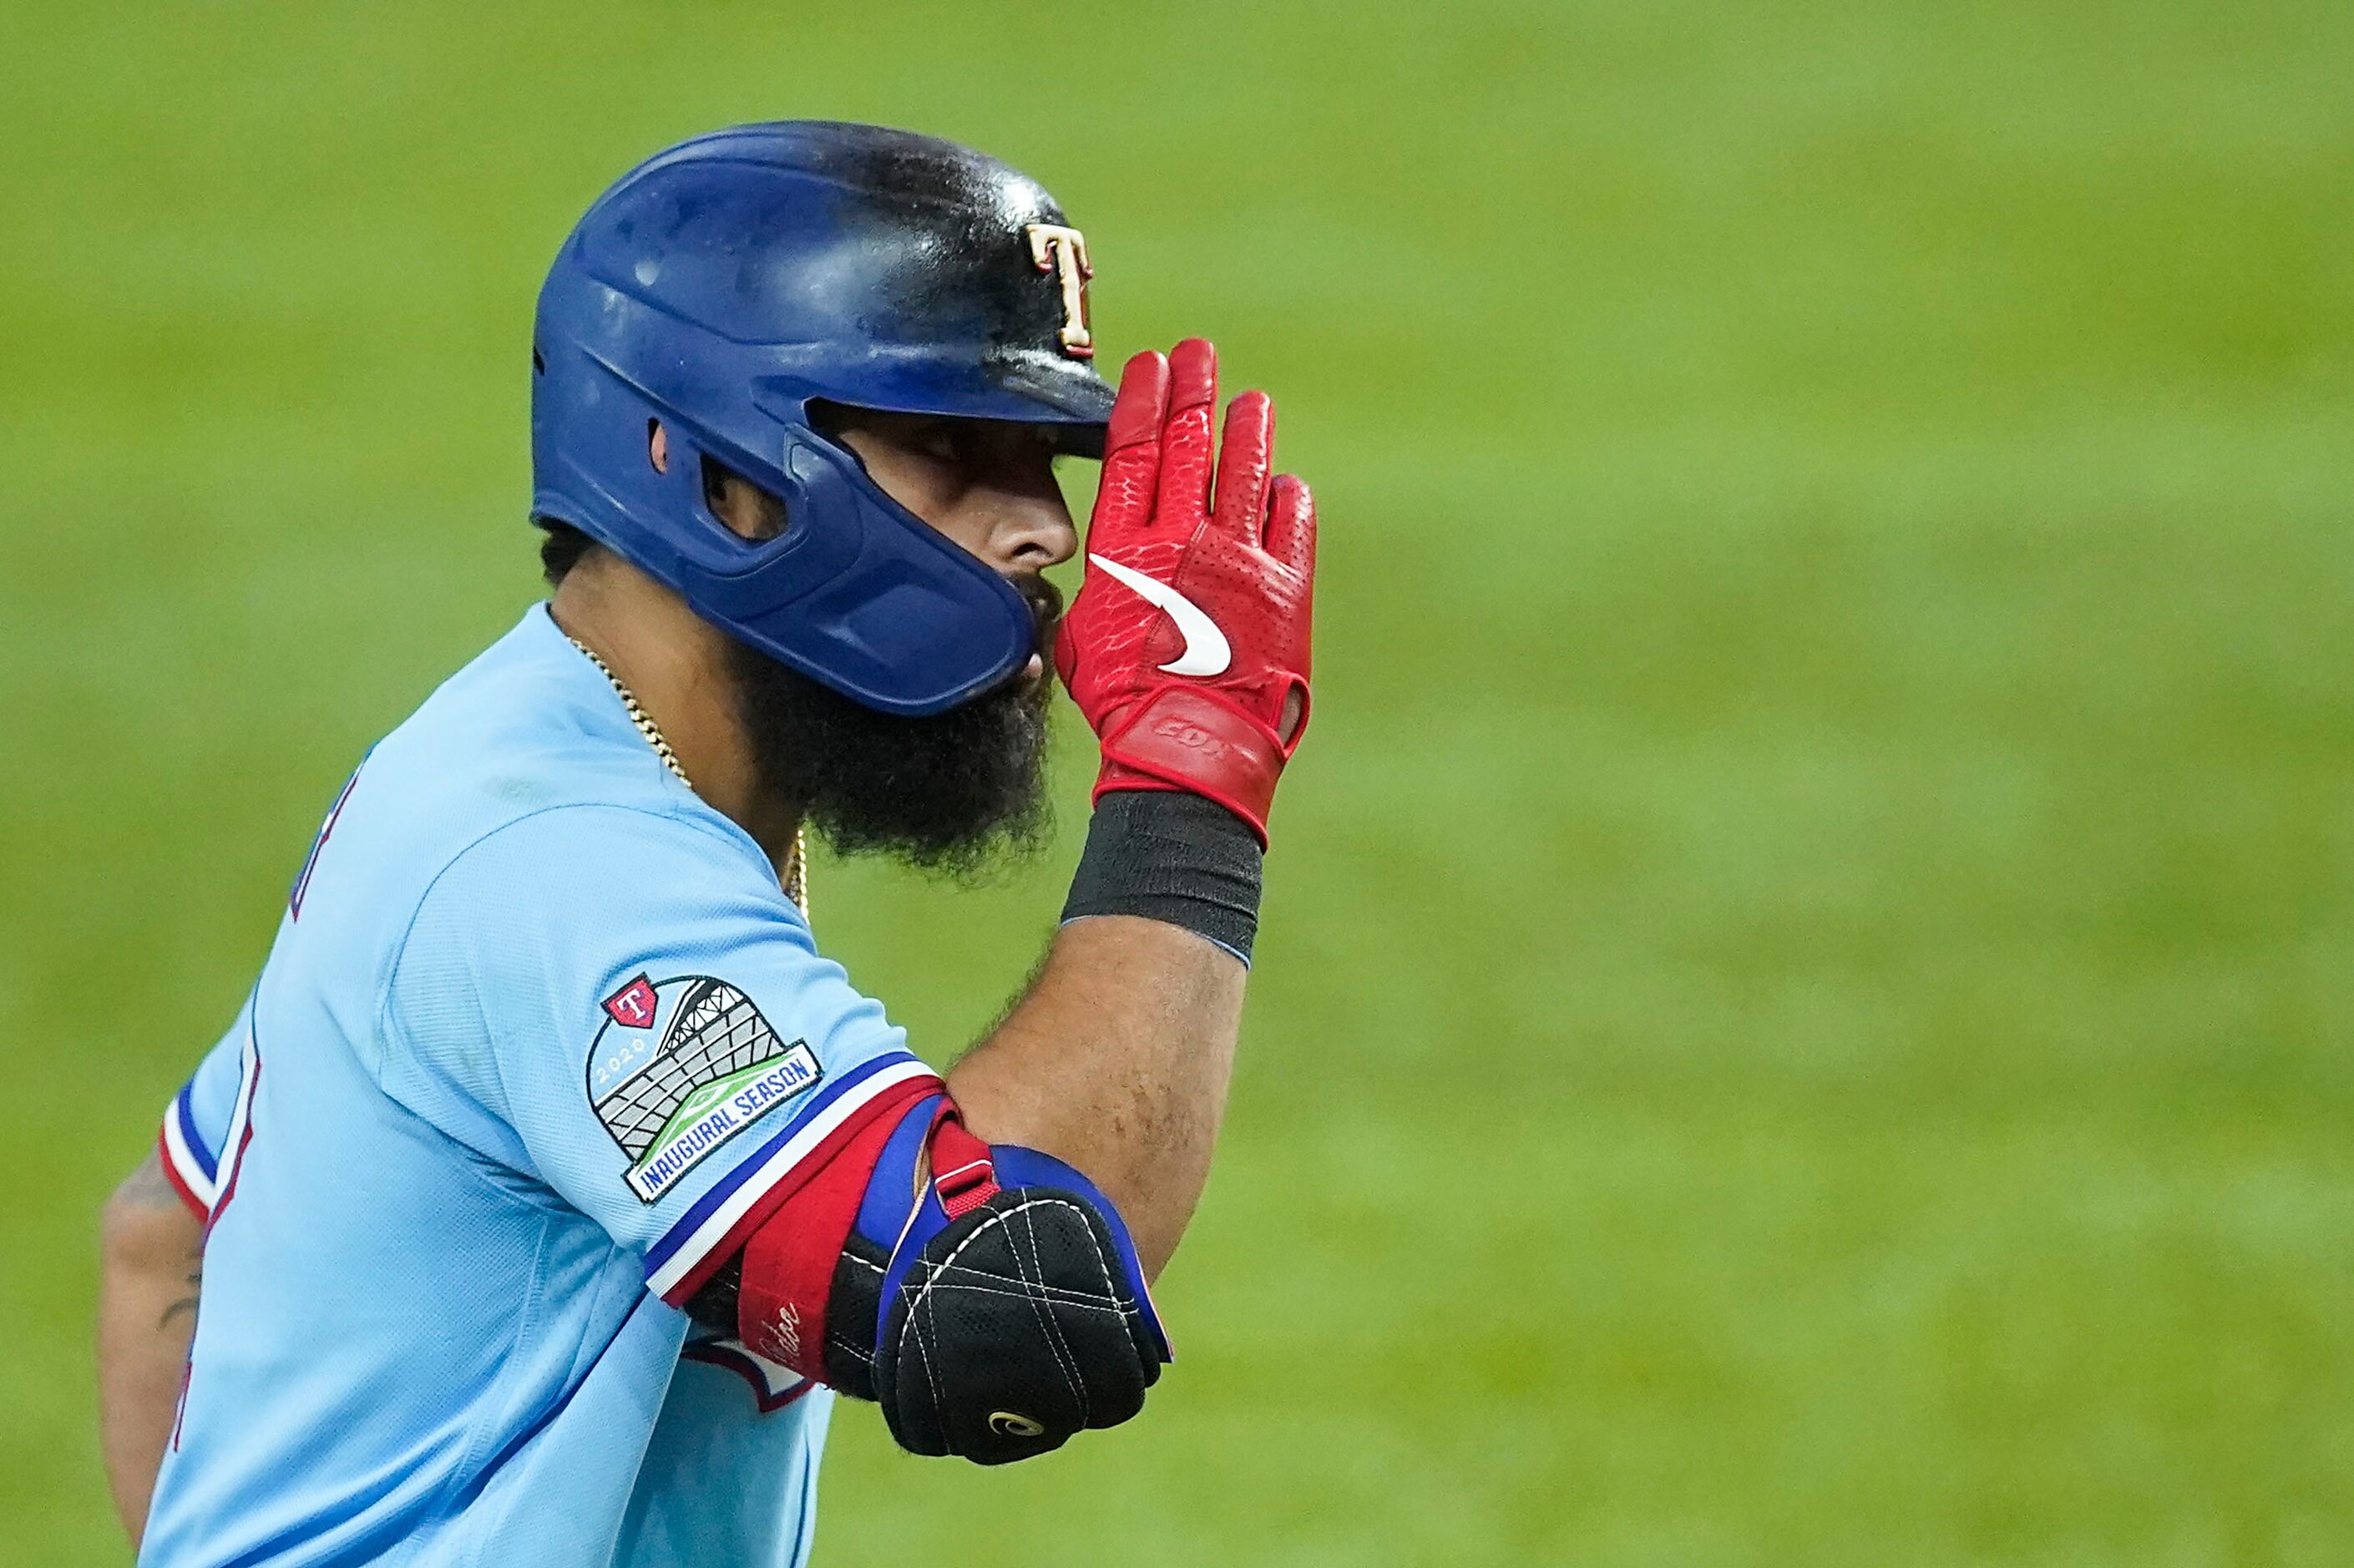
[949,339,1316,1274]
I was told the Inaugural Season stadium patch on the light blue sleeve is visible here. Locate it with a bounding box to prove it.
[589,974,824,1203]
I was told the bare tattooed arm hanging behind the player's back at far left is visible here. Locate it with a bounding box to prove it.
[99,1154,202,1545]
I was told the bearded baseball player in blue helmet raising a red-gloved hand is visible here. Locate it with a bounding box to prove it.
[99,123,1316,1568]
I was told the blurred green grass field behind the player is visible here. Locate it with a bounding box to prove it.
[0,0,2354,1568]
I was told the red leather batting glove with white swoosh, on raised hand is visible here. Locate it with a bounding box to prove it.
[1055,336,1316,842]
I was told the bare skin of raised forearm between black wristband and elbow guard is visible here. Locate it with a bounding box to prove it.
[949,916,1248,1274]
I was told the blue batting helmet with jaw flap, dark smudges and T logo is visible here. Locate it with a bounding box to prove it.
[532,120,1111,713]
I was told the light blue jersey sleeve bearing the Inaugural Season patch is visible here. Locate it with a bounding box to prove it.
[377,805,939,1304]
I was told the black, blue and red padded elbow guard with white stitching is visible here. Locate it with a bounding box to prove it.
[737,1095,1170,1464]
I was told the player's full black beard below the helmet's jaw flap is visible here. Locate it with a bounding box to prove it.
[730,593,1055,881]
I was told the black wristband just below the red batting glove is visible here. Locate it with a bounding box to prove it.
[1061,789,1267,963]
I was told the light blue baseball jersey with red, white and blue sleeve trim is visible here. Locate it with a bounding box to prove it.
[139,608,932,1568]
